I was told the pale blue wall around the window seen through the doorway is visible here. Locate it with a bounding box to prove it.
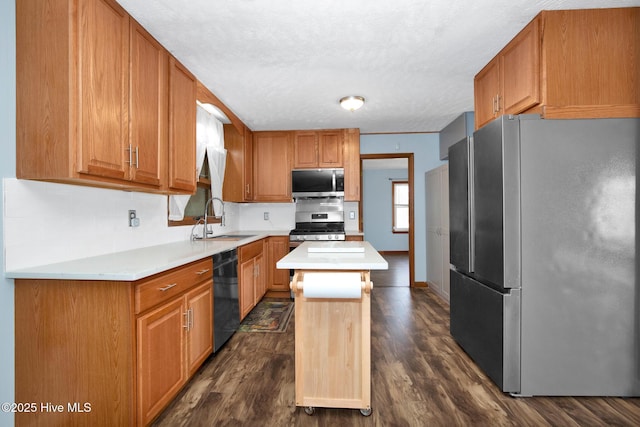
[362,169,409,251]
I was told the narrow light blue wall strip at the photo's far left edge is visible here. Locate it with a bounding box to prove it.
[0,1,16,427]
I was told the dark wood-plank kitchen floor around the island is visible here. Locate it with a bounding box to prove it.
[155,260,640,427]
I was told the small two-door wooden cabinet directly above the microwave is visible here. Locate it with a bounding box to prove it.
[293,130,343,169]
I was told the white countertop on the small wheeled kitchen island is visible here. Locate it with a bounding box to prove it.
[276,241,389,270]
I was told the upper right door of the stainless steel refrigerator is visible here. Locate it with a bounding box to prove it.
[472,116,521,290]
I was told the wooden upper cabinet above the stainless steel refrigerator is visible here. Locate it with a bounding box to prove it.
[474,7,640,129]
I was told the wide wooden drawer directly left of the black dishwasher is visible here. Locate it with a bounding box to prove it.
[135,258,213,314]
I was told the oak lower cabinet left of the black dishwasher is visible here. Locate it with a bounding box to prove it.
[14,258,213,426]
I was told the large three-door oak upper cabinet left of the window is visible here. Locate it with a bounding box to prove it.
[16,0,195,193]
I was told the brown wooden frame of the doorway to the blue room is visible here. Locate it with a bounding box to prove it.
[358,153,415,287]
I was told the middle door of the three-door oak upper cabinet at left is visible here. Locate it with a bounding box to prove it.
[129,20,169,187]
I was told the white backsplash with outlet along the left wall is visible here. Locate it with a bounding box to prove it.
[3,178,239,270]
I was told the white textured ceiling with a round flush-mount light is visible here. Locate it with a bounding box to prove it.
[118,0,640,133]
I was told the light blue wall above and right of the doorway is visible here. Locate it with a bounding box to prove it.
[360,133,446,282]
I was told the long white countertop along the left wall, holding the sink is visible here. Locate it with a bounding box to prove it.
[5,230,289,281]
